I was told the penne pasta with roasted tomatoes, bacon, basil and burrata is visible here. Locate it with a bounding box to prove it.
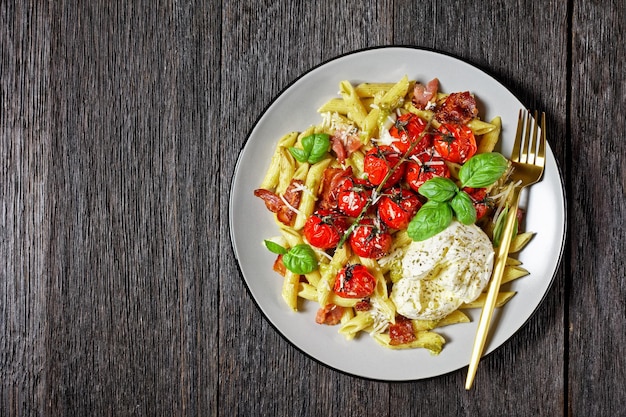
[254,76,533,354]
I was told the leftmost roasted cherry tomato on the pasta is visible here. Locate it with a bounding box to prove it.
[304,210,348,249]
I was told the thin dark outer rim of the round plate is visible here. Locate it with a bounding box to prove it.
[228,44,568,383]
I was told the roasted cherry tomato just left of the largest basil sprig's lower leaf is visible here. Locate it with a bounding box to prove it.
[378,187,422,230]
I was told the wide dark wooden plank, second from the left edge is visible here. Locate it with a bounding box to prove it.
[45,2,220,415]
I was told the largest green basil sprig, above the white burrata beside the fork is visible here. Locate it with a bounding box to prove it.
[407,152,508,241]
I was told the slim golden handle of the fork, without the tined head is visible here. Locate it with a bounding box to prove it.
[465,187,521,390]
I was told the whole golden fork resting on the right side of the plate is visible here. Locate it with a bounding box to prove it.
[465,110,546,390]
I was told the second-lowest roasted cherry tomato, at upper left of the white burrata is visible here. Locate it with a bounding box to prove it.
[350,217,393,259]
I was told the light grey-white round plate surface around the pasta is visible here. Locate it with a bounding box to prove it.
[229,47,565,381]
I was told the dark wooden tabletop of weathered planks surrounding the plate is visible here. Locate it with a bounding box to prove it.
[0,0,626,417]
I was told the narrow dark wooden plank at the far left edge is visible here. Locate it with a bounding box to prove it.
[0,3,52,415]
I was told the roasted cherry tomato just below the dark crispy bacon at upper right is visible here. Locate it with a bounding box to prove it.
[434,123,477,164]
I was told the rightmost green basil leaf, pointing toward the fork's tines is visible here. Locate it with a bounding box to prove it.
[459,152,508,188]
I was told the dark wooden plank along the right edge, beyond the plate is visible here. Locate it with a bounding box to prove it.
[568,1,626,416]
